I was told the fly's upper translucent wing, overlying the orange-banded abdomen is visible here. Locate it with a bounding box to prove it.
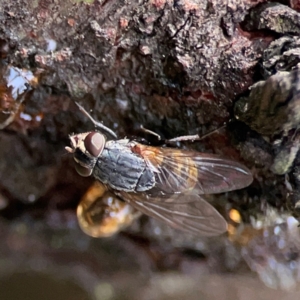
[132,144,252,196]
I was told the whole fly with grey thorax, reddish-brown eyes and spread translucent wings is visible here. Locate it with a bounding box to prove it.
[66,103,253,236]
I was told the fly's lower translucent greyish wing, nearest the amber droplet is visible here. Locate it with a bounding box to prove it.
[119,192,227,236]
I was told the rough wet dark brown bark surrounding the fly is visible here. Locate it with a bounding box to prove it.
[0,0,300,299]
